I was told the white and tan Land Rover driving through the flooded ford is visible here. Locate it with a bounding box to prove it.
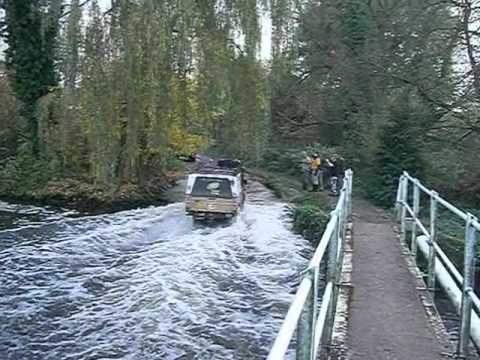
[185,159,245,220]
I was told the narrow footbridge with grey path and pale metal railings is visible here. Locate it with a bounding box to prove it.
[268,170,480,360]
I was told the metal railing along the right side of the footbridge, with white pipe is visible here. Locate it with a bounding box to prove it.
[396,172,480,355]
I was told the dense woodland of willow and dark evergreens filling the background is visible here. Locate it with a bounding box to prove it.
[0,0,480,205]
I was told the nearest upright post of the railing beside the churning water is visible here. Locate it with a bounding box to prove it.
[295,268,318,360]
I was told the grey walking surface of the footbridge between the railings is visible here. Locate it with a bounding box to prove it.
[349,201,447,360]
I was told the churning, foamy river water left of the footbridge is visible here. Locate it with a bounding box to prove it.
[0,183,312,360]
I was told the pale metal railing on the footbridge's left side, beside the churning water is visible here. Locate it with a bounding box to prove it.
[267,170,353,360]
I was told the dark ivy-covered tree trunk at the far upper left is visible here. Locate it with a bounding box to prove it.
[2,0,61,153]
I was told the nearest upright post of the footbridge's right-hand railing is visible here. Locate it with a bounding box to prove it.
[458,213,476,355]
